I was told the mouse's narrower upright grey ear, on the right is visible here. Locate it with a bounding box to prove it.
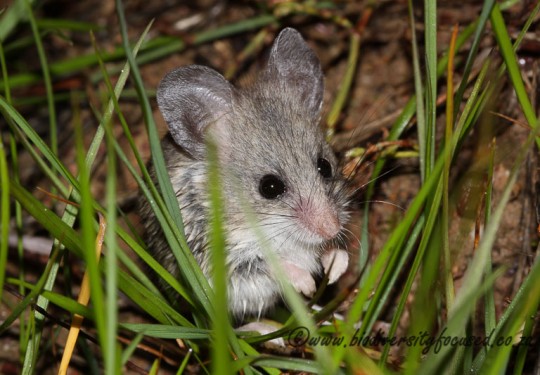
[266,27,324,113]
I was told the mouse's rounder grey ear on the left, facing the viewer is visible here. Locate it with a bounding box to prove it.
[157,65,233,159]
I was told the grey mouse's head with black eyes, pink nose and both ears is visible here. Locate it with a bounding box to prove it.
[157,28,347,251]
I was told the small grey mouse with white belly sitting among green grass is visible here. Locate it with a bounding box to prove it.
[140,28,350,320]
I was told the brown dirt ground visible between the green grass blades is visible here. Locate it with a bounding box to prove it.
[0,0,540,374]
